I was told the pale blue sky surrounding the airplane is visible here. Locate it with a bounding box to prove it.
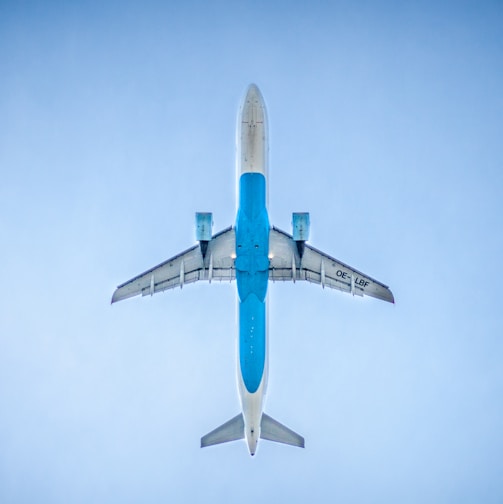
[0,1,503,503]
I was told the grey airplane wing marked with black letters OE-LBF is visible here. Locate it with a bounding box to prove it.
[269,227,395,303]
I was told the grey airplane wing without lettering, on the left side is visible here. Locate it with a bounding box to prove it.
[112,226,236,303]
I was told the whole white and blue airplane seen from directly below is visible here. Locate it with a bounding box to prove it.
[112,84,394,456]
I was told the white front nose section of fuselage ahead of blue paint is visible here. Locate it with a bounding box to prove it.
[237,84,268,178]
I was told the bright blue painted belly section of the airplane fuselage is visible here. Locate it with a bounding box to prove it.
[235,173,269,393]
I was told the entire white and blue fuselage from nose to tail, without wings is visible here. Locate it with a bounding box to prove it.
[236,84,269,455]
